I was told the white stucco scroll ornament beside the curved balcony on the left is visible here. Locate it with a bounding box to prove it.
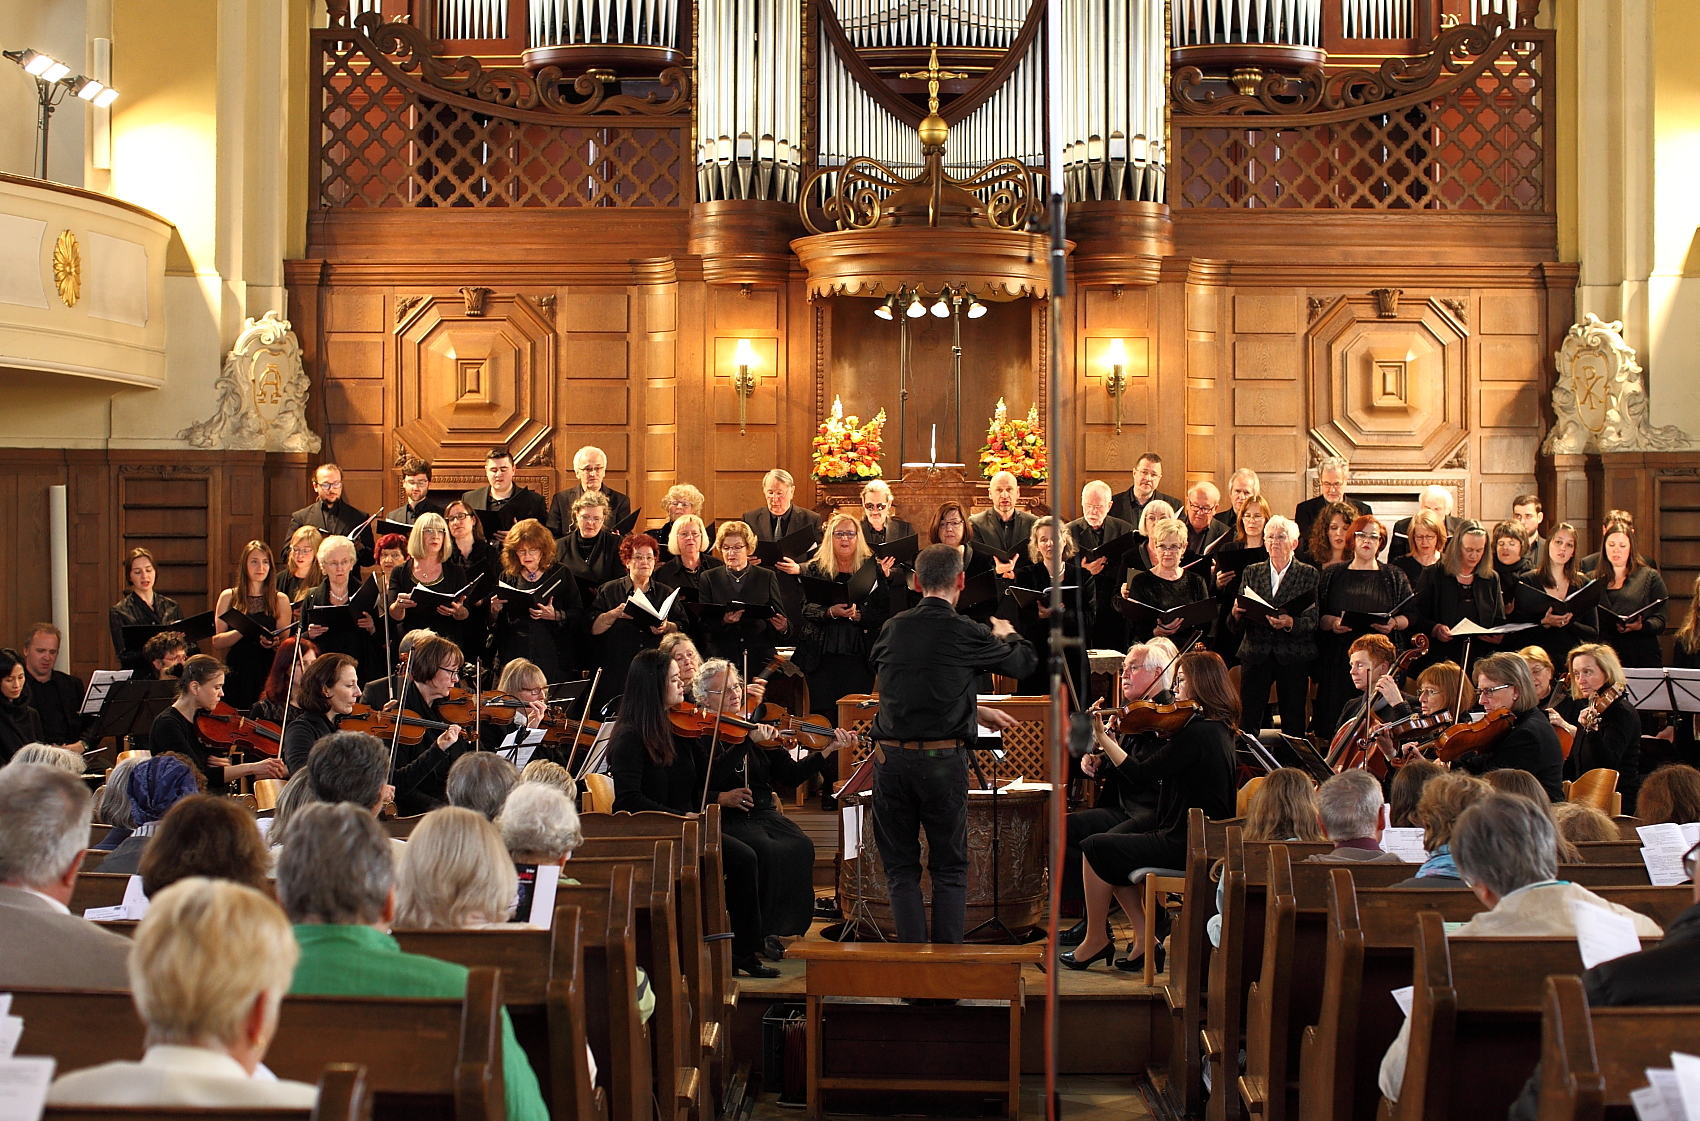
[177,311,320,451]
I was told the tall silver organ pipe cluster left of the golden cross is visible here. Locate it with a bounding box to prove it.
[693,0,802,202]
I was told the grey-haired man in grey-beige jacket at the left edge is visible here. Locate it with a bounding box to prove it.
[0,764,129,990]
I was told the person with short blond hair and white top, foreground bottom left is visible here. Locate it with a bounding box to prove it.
[48,884,318,1109]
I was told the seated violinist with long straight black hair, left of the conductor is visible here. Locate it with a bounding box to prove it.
[609,653,779,976]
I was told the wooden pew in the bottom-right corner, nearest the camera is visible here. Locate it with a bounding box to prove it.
[1539,976,1700,1121]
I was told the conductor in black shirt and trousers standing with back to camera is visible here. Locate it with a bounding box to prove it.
[870,544,1039,942]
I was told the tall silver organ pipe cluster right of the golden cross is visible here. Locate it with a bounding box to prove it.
[1063,0,1169,202]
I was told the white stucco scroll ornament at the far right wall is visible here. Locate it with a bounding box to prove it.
[1540,311,1693,456]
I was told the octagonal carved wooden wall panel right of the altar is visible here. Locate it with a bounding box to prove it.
[1307,296,1467,469]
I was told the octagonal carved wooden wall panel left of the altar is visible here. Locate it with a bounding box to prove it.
[396,296,556,469]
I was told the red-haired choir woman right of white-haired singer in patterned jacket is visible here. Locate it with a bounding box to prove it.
[1311,514,1411,737]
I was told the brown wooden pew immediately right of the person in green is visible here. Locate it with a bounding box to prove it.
[394,903,607,1121]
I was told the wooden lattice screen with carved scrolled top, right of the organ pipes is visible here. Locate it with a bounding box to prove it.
[1170,19,1554,213]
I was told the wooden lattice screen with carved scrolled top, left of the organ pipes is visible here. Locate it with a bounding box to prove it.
[313,15,690,209]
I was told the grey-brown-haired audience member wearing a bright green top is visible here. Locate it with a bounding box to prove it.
[277,803,549,1121]
